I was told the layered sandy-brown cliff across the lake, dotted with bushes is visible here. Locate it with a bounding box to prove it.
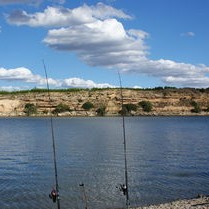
[0,88,209,117]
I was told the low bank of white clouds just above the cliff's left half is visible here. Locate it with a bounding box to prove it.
[0,67,114,90]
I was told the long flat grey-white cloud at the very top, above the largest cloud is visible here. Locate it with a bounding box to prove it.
[7,3,130,27]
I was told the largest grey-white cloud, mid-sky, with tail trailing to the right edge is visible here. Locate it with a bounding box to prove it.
[44,16,208,87]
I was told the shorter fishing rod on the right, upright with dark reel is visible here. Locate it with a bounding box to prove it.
[118,72,130,209]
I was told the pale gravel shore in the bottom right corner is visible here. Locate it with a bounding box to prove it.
[136,196,209,209]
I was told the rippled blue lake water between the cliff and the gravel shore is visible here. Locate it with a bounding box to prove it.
[0,117,209,209]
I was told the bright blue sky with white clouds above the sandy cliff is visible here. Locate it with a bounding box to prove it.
[0,0,209,90]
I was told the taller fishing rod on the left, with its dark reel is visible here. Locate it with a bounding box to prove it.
[43,60,61,209]
